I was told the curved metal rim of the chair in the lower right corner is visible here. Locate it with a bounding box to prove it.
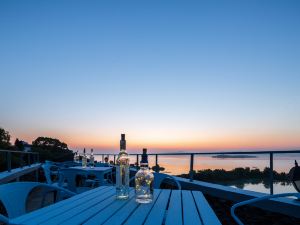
[230,193,300,225]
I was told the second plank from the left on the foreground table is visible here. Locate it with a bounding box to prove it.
[42,189,115,225]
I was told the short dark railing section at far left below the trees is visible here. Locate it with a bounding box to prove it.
[0,149,39,172]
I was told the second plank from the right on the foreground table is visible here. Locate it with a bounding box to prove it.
[182,191,202,225]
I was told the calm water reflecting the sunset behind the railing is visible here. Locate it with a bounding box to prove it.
[97,153,300,193]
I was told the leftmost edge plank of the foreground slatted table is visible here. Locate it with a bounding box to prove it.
[12,186,112,224]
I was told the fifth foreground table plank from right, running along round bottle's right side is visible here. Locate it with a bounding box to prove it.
[124,189,161,225]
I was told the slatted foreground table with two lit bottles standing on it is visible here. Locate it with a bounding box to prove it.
[11,186,221,225]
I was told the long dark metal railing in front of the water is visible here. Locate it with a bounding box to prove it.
[95,150,300,194]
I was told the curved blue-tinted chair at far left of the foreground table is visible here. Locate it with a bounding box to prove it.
[0,182,75,221]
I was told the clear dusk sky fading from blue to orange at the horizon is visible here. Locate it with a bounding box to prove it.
[0,0,300,152]
